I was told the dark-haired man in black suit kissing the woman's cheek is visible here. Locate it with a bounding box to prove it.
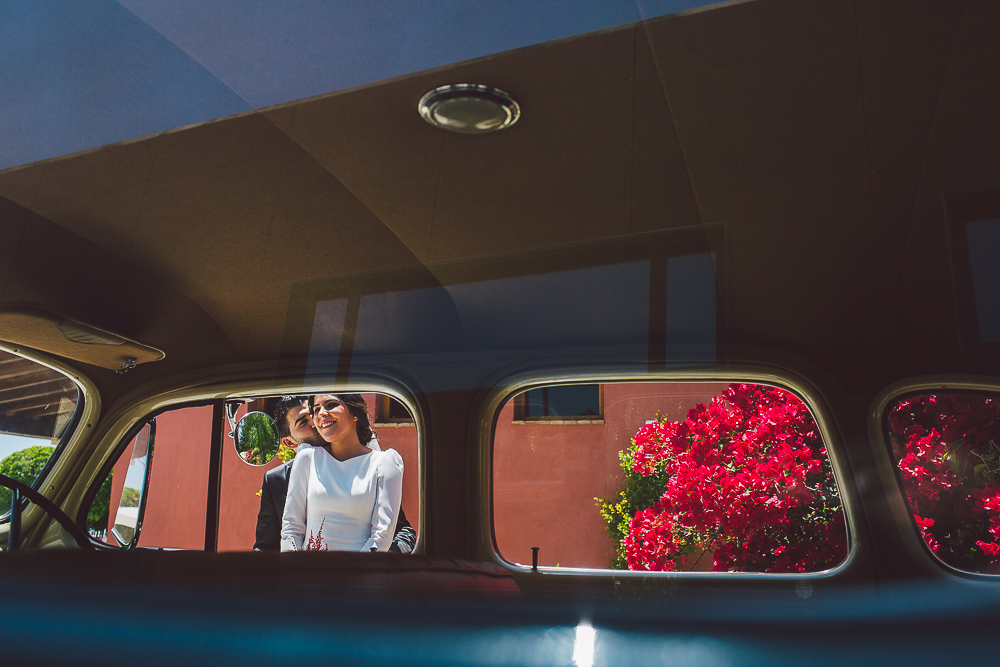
[253,396,417,554]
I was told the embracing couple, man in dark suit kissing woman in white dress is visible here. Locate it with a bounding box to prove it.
[254,394,416,553]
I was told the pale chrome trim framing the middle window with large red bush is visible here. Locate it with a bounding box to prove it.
[473,365,863,582]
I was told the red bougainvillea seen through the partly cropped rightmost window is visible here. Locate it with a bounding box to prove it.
[885,393,1000,574]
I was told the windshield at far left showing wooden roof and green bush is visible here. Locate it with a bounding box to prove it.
[0,350,82,514]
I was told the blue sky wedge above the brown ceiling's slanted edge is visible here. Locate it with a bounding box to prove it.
[0,0,713,169]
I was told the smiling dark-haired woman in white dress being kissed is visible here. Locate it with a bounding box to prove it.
[281,394,403,551]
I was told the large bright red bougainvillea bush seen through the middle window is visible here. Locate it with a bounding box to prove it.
[605,384,847,572]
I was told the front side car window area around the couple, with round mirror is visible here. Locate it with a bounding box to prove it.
[88,393,420,551]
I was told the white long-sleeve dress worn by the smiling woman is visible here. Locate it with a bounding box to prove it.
[281,444,403,551]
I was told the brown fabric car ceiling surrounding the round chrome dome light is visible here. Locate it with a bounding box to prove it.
[0,0,1000,408]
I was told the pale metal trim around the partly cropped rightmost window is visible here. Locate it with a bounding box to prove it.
[868,375,1000,582]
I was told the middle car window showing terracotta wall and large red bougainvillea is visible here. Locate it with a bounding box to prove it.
[493,382,847,572]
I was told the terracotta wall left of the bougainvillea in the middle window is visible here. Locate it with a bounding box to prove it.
[493,383,728,567]
